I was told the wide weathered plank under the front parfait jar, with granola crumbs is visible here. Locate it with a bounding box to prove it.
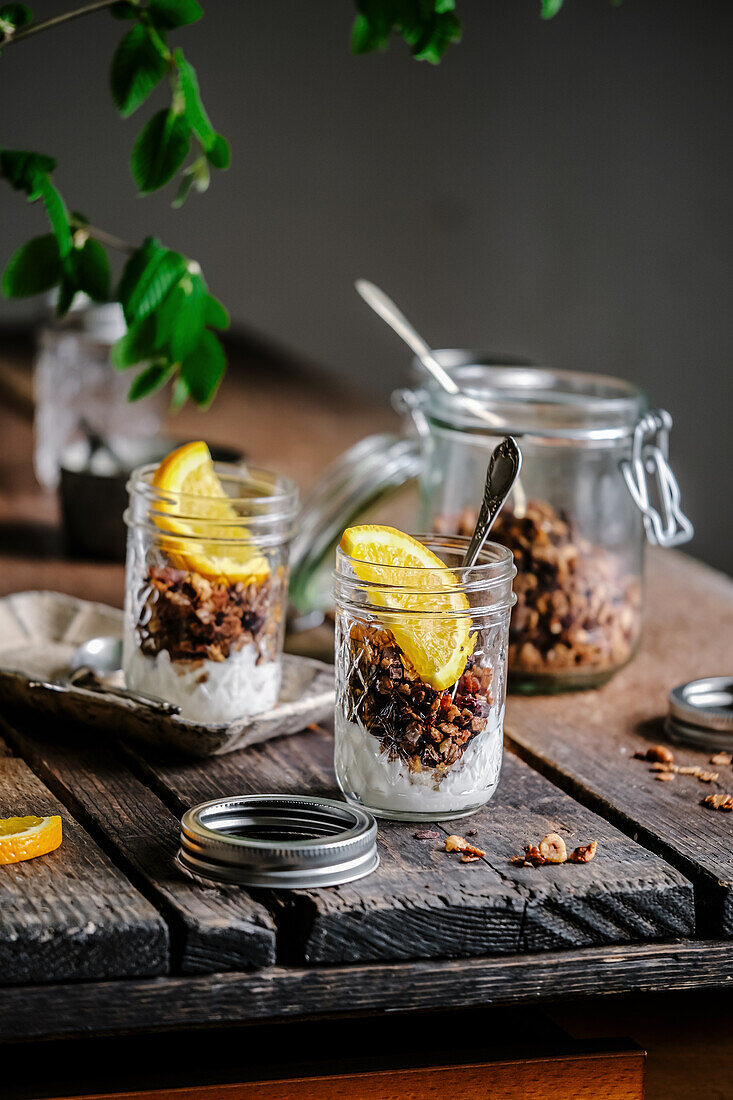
[124,730,694,963]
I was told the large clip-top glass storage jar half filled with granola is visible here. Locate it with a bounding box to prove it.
[400,352,691,692]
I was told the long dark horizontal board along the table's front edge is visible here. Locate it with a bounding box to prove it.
[0,941,733,1042]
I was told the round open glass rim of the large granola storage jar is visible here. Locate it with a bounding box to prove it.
[407,348,648,441]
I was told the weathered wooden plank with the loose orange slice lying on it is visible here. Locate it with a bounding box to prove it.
[0,755,169,985]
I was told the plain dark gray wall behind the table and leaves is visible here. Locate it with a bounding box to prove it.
[0,0,733,568]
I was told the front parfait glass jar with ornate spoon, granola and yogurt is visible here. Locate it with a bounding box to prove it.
[333,536,515,821]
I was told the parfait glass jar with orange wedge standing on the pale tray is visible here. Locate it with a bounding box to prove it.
[123,463,298,725]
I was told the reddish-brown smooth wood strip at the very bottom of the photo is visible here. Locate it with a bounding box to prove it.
[52,1049,644,1100]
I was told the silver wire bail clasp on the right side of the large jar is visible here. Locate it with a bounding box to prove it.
[621,409,694,547]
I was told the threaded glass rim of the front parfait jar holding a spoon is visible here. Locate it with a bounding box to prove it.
[332,534,516,617]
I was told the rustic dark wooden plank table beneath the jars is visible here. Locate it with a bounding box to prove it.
[0,336,733,1097]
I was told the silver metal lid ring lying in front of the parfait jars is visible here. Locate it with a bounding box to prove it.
[176,794,380,889]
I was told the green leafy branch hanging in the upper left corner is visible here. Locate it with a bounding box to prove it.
[0,0,229,407]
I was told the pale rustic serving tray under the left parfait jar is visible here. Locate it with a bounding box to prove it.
[0,592,333,757]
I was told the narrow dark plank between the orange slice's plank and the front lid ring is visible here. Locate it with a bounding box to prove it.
[3,717,275,974]
